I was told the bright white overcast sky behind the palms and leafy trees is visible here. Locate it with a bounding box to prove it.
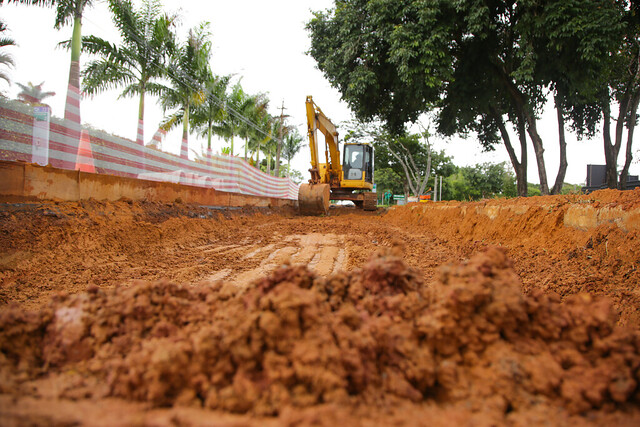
[0,0,640,186]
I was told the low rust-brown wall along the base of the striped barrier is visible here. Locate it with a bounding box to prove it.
[0,161,296,207]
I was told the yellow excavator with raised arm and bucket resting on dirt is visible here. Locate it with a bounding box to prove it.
[298,96,377,215]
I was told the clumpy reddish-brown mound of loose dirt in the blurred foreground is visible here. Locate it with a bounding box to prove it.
[0,247,640,422]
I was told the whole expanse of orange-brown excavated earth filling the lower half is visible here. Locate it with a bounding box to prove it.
[0,190,640,426]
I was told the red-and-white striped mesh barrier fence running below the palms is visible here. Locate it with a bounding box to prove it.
[0,99,298,200]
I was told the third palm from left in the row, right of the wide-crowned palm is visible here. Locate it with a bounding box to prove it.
[160,22,211,159]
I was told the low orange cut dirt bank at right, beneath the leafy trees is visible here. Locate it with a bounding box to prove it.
[390,190,640,252]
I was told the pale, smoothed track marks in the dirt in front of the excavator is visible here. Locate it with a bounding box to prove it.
[204,233,348,287]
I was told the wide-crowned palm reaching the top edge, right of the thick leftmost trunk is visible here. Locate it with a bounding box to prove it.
[82,0,176,145]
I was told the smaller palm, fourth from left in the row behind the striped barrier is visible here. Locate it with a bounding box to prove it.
[190,73,231,156]
